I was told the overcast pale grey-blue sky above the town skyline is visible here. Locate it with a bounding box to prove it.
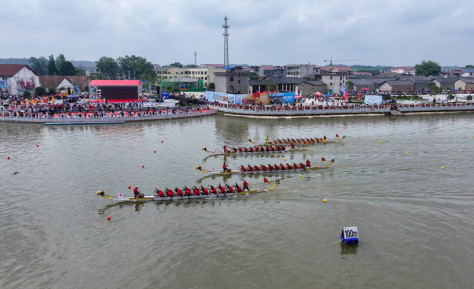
[0,0,474,66]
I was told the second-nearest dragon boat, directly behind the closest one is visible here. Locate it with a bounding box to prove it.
[196,159,334,175]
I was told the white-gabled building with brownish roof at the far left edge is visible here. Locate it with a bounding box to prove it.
[0,64,41,95]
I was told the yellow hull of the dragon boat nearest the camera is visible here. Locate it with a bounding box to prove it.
[96,180,280,202]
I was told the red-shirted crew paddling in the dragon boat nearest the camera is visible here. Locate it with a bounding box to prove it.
[133,181,250,198]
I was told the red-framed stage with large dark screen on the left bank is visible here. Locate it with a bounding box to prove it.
[90,80,141,102]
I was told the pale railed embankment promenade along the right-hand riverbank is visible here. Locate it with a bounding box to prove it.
[210,103,474,117]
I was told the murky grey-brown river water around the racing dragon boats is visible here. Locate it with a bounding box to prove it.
[0,114,474,289]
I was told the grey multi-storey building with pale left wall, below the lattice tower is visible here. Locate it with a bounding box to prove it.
[215,66,249,94]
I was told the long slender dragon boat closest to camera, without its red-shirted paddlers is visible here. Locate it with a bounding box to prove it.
[96,180,280,202]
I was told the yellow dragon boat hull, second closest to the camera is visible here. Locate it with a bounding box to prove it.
[196,159,334,175]
